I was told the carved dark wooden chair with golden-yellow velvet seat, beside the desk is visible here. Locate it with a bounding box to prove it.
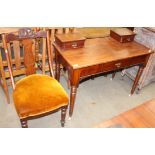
[2,29,68,128]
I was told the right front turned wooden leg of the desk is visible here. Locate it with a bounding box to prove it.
[131,66,144,95]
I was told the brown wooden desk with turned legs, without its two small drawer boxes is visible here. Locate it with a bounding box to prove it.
[54,37,152,117]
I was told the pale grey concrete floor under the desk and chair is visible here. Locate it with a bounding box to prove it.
[0,72,155,128]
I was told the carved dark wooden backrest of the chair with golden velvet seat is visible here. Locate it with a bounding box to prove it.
[2,28,54,89]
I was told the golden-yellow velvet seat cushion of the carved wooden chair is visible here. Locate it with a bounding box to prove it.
[13,74,68,119]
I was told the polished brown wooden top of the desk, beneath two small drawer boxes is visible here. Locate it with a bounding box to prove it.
[54,37,152,68]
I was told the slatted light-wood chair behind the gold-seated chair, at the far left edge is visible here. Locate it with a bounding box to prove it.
[0,28,36,103]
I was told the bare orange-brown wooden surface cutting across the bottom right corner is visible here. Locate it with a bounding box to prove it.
[95,99,155,128]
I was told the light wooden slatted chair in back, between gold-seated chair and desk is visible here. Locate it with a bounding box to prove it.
[35,27,76,88]
